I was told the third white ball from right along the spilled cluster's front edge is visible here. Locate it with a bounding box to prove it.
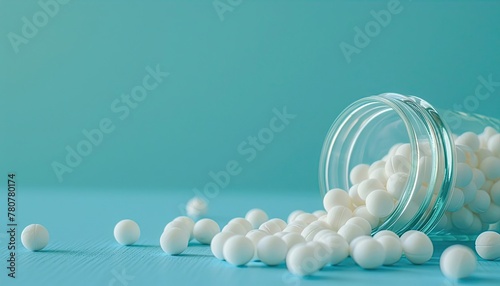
[352,238,385,269]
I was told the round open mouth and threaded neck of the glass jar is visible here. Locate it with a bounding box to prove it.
[319,93,455,233]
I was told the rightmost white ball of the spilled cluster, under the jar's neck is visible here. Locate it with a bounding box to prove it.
[401,231,434,264]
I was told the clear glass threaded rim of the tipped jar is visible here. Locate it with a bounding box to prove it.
[319,93,456,235]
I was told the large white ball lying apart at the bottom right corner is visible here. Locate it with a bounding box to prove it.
[439,244,477,279]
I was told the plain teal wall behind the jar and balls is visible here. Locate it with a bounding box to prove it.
[0,0,500,192]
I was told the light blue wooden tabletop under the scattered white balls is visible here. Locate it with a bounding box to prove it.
[0,190,500,286]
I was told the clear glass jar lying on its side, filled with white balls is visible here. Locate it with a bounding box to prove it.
[319,93,500,240]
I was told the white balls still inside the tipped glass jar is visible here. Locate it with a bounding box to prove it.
[344,127,500,234]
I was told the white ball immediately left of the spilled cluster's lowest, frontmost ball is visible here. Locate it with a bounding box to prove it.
[257,235,288,266]
